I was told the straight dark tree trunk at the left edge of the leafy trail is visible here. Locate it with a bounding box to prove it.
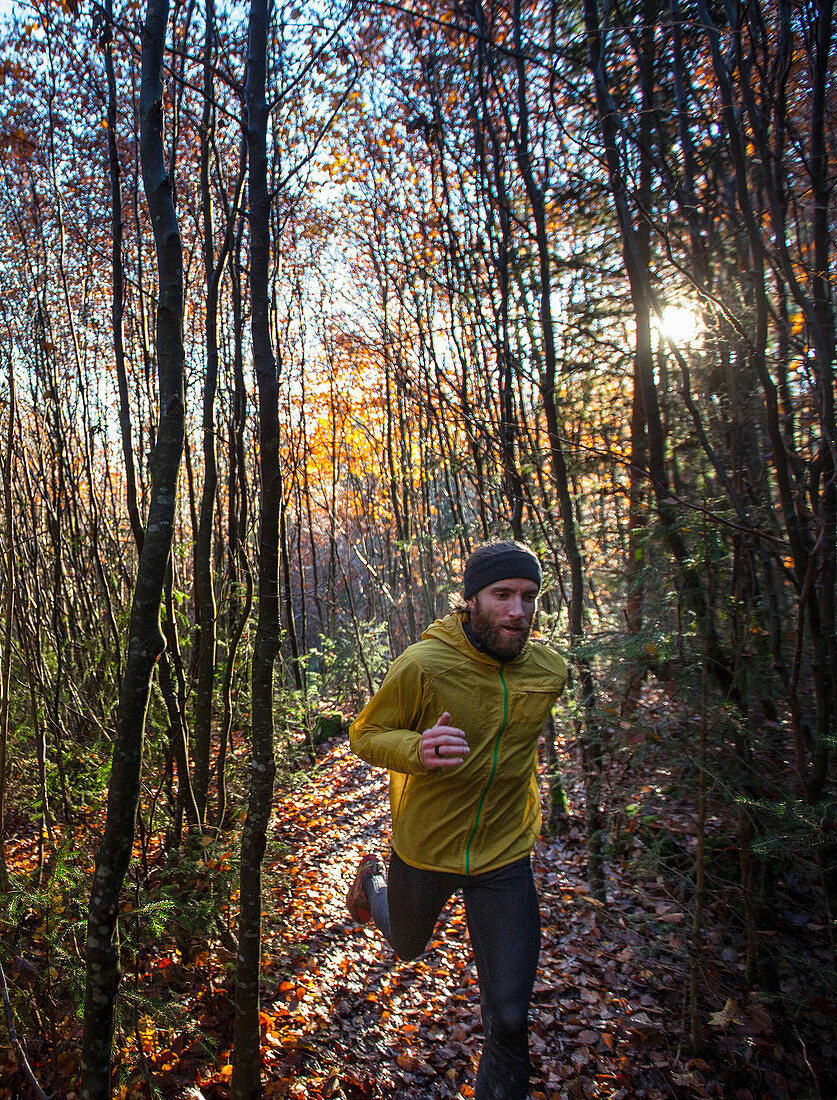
[231,0,280,1100]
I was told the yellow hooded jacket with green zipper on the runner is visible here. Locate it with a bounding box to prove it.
[350,612,566,875]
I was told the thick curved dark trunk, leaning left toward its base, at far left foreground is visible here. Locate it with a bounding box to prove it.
[80,0,184,1100]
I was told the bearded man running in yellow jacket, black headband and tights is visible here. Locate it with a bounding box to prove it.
[346,542,566,1100]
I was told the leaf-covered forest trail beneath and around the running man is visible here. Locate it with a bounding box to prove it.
[255,743,703,1100]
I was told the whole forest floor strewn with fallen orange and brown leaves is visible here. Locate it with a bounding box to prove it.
[0,721,837,1100]
